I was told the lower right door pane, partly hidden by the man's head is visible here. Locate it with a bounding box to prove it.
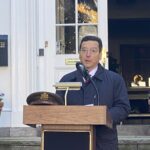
[78,25,98,44]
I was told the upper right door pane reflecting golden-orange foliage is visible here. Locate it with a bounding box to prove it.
[77,0,98,23]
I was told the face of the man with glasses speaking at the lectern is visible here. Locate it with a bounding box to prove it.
[79,41,101,71]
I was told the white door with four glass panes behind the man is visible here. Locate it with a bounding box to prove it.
[37,0,108,91]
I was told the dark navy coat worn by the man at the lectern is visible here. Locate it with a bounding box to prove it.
[56,64,130,150]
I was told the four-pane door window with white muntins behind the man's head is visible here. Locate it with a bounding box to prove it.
[56,0,98,54]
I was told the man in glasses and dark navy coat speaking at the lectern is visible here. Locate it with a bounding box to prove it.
[57,36,130,150]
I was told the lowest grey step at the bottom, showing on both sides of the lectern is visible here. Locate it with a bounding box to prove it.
[0,136,150,150]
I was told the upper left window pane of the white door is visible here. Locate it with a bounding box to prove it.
[56,0,75,24]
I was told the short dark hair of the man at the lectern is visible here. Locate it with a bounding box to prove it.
[79,35,103,52]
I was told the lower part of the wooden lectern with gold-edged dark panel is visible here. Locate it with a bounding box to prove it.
[42,125,95,150]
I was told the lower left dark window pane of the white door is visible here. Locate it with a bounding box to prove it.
[56,26,76,54]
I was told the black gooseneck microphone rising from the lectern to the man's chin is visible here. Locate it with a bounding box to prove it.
[76,62,99,105]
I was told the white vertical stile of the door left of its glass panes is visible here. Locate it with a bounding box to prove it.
[44,0,59,92]
